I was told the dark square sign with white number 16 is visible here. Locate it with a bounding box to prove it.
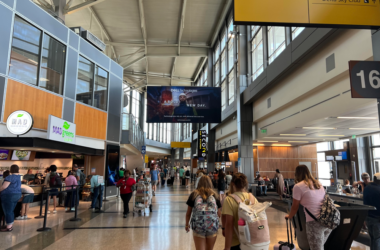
[348,61,380,98]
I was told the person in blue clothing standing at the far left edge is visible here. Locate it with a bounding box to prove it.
[0,165,21,232]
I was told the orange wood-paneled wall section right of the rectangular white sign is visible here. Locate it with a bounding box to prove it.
[74,103,107,140]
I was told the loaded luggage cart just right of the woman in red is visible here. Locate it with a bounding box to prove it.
[133,181,152,216]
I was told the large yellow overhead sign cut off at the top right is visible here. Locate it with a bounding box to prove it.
[234,0,380,28]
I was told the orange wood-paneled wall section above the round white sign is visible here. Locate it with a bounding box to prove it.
[3,79,63,130]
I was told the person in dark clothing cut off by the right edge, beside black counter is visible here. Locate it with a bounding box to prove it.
[363,173,380,250]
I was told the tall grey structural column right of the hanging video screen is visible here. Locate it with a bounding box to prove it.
[236,26,254,183]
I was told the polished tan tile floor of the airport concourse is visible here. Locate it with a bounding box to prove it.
[0,181,369,250]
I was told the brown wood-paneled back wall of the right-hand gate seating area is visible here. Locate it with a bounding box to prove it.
[254,144,317,179]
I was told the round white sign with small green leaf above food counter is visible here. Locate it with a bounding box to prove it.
[7,110,34,135]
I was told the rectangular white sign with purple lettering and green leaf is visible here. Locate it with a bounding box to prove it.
[47,115,76,144]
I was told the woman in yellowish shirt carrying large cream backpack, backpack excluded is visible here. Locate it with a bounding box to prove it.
[222,173,258,250]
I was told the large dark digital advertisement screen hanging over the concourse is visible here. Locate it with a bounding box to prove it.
[146,86,222,123]
